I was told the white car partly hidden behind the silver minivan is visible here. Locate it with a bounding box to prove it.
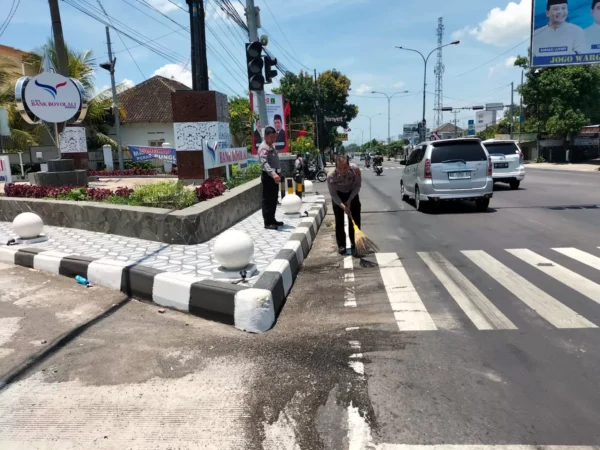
[482,139,525,189]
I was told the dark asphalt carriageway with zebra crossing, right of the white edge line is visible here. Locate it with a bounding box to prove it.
[318,163,600,448]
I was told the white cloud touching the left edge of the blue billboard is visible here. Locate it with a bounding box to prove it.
[452,0,531,47]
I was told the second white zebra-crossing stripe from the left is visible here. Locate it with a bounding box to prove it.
[418,252,517,330]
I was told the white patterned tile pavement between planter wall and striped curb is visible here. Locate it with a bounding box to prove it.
[0,197,323,285]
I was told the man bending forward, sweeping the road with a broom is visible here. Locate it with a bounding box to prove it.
[327,155,362,255]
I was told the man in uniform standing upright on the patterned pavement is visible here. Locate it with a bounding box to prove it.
[258,127,283,230]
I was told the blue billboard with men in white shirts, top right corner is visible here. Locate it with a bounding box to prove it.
[531,0,600,67]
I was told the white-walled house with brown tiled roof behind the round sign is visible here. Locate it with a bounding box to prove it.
[109,75,190,147]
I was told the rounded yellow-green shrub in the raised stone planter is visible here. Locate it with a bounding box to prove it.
[129,181,197,209]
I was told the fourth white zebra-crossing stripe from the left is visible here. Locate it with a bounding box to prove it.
[506,249,600,303]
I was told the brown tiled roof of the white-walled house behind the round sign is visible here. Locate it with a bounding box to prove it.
[118,75,190,123]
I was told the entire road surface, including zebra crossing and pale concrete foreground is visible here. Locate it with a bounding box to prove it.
[0,163,600,450]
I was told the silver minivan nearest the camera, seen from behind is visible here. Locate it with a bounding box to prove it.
[400,138,494,211]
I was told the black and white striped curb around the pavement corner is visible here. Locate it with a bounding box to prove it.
[0,198,326,333]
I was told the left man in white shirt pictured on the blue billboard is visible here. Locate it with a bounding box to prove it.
[532,0,586,57]
